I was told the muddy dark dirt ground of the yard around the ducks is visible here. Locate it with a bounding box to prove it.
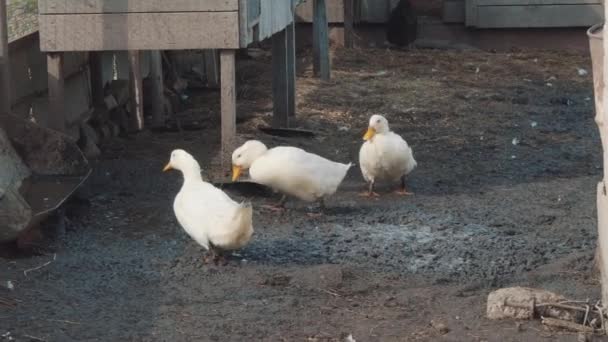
[0,49,602,341]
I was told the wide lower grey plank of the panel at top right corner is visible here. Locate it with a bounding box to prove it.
[475,5,603,28]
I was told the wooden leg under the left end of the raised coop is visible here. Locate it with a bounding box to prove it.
[46,52,66,132]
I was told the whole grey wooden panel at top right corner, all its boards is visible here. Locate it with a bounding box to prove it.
[466,0,603,28]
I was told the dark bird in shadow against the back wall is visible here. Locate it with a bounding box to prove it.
[386,0,418,46]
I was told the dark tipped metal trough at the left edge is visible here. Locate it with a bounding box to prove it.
[0,115,91,242]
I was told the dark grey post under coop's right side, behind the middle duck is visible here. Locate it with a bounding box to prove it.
[272,23,296,128]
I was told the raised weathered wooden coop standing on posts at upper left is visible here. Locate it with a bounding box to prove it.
[39,0,329,168]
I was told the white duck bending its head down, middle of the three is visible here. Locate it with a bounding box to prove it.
[232,140,352,209]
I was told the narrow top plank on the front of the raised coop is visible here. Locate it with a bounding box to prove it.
[38,0,239,14]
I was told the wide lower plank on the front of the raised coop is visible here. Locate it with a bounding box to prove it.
[39,12,239,51]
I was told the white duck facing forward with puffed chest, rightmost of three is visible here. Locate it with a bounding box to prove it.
[359,115,417,196]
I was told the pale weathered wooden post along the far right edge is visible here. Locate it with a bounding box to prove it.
[594,6,608,306]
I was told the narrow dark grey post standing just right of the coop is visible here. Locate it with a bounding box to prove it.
[312,0,330,80]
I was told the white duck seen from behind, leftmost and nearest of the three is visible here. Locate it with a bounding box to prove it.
[163,150,253,263]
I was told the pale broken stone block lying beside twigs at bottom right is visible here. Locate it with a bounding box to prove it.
[487,287,573,320]
